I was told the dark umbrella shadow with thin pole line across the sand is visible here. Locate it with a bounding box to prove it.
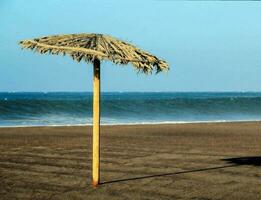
[100,156,261,185]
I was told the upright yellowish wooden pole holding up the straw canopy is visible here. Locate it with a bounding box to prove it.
[92,59,100,187]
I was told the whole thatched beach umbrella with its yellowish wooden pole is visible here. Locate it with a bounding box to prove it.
[20,34,168,186]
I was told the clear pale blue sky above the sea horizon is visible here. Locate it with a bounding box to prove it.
[0,0,261,91]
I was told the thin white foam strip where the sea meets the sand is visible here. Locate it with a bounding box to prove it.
[0,119,261,129]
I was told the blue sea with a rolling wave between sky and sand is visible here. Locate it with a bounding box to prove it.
[0,92,261,126]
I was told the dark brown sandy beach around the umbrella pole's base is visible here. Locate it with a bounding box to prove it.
[0,122,261,200]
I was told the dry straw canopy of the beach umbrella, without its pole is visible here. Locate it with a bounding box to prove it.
[20,33,169,73]
